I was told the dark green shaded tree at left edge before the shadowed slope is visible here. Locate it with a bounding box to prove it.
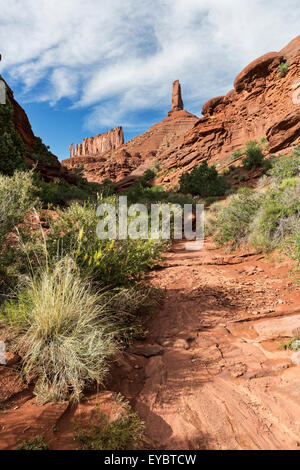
[0,90,26,175]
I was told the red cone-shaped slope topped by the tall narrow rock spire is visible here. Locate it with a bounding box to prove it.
[62,81,198,186]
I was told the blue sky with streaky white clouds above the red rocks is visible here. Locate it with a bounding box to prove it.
[0,0,300,160]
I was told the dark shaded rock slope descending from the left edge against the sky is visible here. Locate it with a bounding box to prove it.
[0,79,76,183]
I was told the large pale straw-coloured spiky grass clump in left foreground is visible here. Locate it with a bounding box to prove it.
[1,257,117,403]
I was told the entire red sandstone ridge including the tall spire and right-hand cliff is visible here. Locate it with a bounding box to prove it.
[62,36,300,187]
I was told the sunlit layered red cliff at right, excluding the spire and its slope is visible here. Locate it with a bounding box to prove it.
[158,36,300,184]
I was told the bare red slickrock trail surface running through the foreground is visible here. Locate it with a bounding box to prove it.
[108,241,300,450]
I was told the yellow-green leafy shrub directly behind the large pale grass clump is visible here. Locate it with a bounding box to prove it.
[29,197,166,286]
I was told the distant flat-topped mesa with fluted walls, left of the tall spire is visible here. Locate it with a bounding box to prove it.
[69,127,124,158]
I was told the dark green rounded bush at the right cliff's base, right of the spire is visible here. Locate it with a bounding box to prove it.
[180,160,229,197]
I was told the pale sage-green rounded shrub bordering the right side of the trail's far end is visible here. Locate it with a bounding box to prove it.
[214,188,260,248]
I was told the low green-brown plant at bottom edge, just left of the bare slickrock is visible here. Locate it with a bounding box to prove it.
[75,407,144,450]
